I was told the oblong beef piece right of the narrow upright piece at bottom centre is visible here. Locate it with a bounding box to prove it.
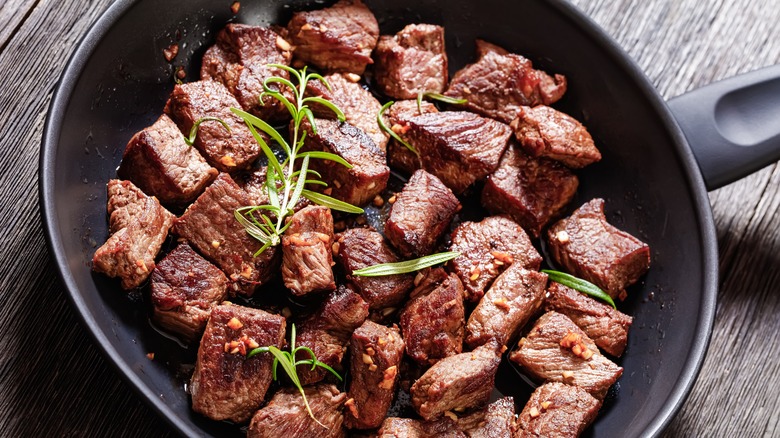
[411,346,501,420]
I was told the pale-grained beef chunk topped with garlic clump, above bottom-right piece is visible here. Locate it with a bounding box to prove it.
[510,311,623,399]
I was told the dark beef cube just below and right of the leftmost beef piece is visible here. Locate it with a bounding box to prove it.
[151,243,228,342]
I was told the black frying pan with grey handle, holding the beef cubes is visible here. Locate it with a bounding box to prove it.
[40,0,780,437]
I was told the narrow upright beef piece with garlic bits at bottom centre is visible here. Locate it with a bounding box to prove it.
[345,321,404,429]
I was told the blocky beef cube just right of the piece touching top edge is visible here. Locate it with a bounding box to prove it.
[374,24,447,99]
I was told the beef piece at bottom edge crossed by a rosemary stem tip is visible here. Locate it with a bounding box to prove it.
[246,384,347,438]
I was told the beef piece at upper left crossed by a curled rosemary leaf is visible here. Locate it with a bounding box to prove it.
[165,81,265,172]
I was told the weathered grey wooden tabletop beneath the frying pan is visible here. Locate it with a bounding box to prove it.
[0,0,780,437]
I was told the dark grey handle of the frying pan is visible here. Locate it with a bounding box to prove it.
[669,65,780,190]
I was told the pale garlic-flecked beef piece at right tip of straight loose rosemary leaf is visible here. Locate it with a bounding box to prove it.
[452,216,542,302]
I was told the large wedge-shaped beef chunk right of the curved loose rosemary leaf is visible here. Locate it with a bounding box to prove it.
[404,111,512,195]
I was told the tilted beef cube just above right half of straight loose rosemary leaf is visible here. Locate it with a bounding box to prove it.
[385,170,461,258]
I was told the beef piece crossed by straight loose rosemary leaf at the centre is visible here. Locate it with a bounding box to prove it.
[334,228,414,310]
